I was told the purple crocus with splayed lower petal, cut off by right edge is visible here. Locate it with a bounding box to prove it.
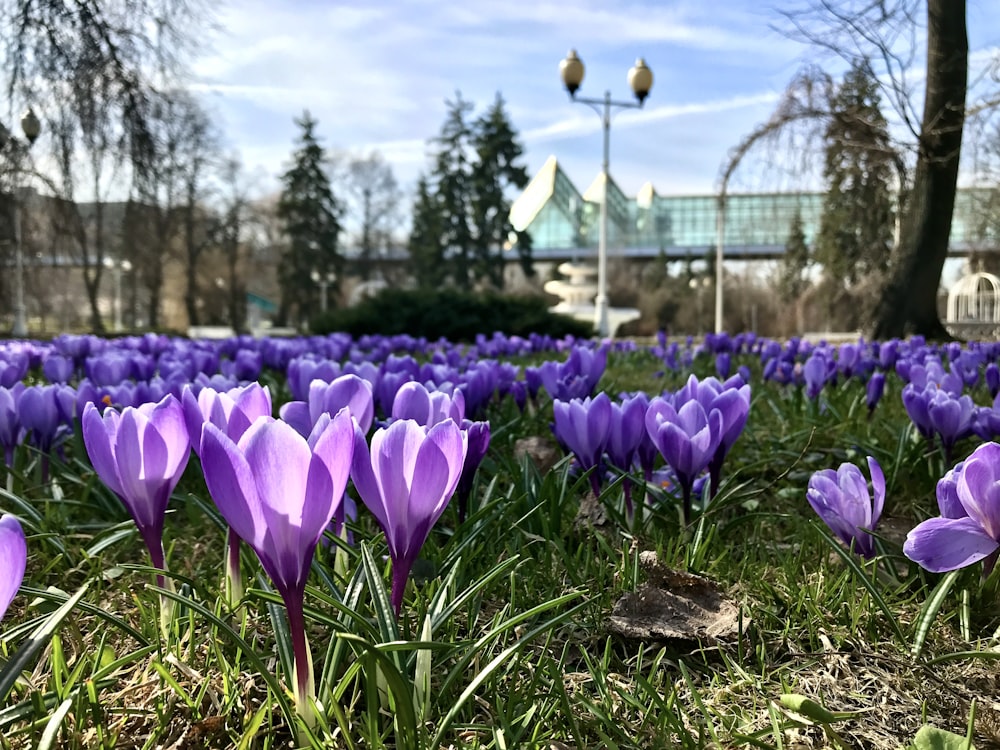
[903,443,1000,577]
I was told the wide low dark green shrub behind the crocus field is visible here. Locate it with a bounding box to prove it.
[311,289,593,341]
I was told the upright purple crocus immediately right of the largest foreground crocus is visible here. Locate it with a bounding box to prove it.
[351,419,468,616]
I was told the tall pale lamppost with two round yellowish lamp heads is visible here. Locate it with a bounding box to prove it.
[559,50,653,338]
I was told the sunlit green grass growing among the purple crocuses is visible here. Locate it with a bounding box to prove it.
[0,353,1000,749]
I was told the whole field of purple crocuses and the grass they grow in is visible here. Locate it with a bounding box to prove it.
[0,334,1000,750]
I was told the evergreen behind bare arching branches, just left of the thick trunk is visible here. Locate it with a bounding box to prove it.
[815,61,893,286]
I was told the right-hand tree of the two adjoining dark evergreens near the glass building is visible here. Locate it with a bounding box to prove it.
[472,93,534,289]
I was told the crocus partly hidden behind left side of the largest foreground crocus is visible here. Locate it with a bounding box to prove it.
[181,383,271,607]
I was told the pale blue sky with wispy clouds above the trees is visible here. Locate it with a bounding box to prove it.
[193,0,1000,203]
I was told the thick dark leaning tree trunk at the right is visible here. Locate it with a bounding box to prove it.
[872,0,969,339]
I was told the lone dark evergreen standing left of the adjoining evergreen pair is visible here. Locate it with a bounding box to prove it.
[278,111,344,325]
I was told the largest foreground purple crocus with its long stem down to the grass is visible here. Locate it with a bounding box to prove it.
[201,410,354,725]
